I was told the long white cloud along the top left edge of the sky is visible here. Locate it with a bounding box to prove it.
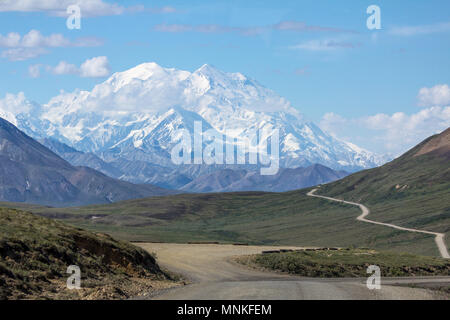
[0,0,176,17]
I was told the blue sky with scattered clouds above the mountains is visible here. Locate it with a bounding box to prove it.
[0,0,450,154]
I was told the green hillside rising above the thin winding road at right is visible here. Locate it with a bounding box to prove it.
[318,131,450,251]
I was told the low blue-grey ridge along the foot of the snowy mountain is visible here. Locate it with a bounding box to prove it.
[40,139,348,192]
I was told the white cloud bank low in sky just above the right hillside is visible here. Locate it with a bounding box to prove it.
[320,106,450,156]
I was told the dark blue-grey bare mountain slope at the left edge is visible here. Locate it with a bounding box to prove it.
[0,118,173,206]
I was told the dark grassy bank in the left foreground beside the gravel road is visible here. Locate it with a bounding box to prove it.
[0,208,174,299]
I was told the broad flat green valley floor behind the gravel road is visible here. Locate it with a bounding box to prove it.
[13,190,438,255]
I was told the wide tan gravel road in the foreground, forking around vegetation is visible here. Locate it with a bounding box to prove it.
[136,243,450,300]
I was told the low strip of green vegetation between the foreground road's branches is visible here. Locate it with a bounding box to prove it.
[236,249,450,277]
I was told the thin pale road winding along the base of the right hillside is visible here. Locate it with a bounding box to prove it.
[307,189,450,259]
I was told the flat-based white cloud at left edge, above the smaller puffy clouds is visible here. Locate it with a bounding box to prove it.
[0,30,103,61]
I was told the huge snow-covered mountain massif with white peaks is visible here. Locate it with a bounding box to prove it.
[0,63,383,181]
